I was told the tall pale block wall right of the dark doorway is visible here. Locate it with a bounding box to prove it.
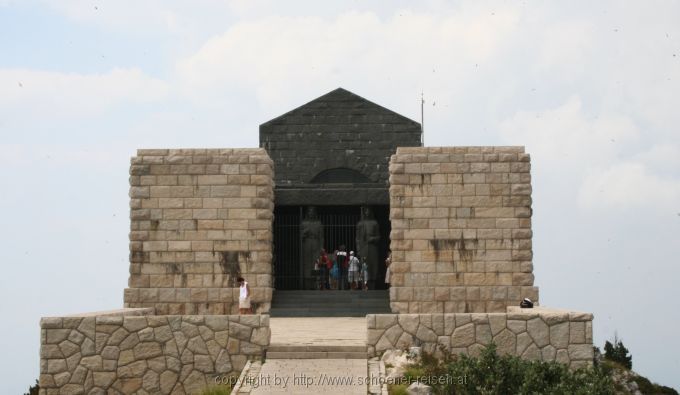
[390,147,538,313]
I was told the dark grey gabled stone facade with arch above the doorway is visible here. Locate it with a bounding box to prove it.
[260,88,421,206]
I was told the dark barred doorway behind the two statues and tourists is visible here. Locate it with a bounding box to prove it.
[274,206,391,290]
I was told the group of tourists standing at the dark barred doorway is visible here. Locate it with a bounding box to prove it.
[314,246,391,291]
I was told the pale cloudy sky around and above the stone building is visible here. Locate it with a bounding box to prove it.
[0,0,680,393]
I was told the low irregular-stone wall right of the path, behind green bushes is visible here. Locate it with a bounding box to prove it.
[366,308,593,368]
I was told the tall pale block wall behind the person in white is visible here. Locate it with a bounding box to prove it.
[124,148,274,314]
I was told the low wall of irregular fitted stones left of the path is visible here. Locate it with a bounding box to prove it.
[40,310,270,395]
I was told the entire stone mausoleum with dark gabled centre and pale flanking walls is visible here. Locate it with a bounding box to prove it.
[40,88,592,394]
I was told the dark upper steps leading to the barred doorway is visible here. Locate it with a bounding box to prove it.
[270,290,390,317]
